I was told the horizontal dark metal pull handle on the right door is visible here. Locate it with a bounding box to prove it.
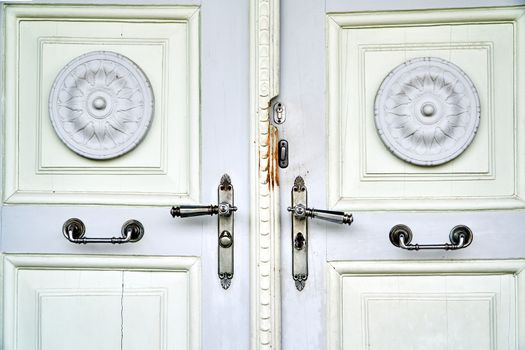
[389,224,474,250]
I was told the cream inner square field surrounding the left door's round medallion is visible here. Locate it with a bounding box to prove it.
[37,38,168,172]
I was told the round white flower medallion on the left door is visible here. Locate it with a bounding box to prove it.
[49,51,154,159]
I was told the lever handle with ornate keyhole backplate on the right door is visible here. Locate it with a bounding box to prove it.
[288,176,354,291]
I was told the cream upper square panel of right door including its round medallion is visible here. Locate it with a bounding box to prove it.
[326,8,525,210]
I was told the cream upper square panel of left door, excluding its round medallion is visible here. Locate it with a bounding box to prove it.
[4,5,200,205]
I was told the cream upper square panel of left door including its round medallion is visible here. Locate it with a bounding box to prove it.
[4,5,200,205]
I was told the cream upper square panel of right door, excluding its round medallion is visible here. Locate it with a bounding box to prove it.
[327,9,524,210]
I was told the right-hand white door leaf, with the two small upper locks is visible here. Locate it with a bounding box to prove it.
[277,0,525,350]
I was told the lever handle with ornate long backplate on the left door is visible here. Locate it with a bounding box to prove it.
[170,174,237,289]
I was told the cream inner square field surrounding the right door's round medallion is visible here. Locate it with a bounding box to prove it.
[359,43,494,180]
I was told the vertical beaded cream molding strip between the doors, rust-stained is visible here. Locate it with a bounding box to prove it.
[250,0,281,349]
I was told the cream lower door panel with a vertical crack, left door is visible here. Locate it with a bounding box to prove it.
[4,255,201,350]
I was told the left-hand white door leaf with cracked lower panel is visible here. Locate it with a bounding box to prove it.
[1,1,250,350]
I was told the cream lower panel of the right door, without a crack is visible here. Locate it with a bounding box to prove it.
[328,261,525,350]
